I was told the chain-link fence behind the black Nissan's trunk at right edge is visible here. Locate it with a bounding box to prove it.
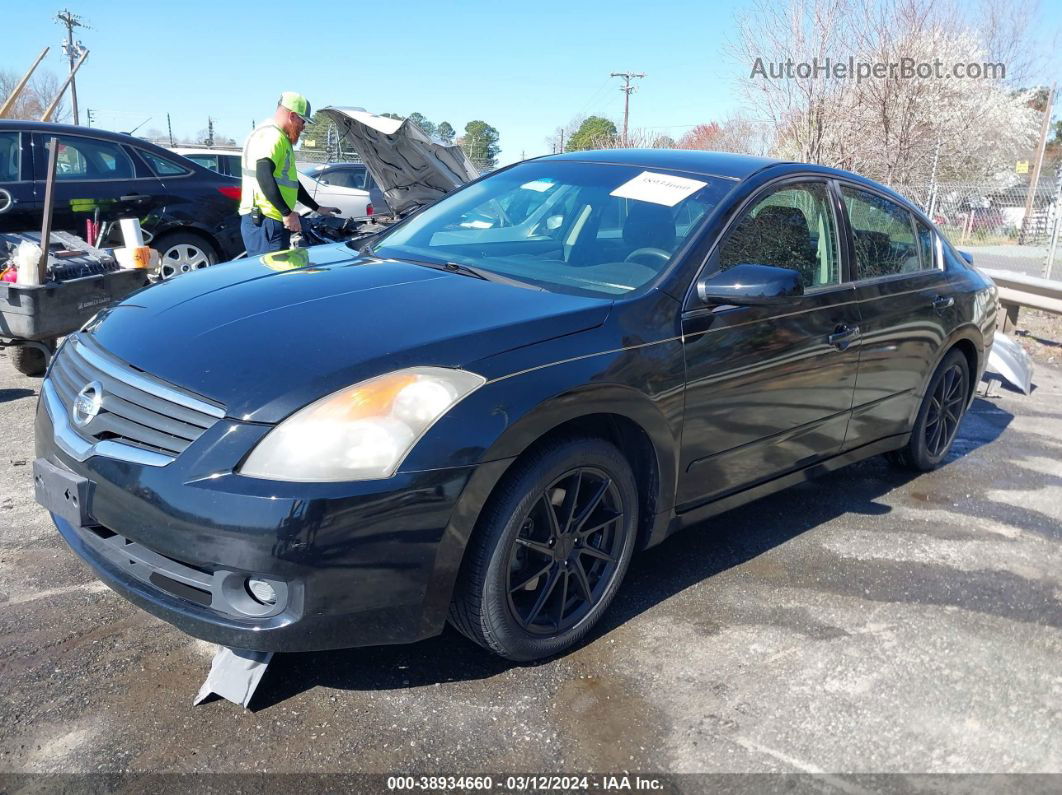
[890,176,1062,279]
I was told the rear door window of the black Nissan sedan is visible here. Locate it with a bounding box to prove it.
[841,185,923,279]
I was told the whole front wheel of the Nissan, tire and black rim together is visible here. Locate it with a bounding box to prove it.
[449,437,638,662]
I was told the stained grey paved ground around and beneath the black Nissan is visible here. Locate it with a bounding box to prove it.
[0,355,1062,791]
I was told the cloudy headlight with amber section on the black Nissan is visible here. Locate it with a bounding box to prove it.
[239,367,486,482]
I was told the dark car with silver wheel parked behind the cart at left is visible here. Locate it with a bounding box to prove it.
[0,120,243,269]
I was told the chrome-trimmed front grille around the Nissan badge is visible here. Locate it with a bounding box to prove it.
[48,335,225,459]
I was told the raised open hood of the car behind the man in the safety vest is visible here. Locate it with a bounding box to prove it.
[321,106,479,215]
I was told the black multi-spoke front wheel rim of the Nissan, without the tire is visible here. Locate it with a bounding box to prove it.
[507,467,626,635]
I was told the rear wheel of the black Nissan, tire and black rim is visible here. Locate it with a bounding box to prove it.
[887,349,970,472]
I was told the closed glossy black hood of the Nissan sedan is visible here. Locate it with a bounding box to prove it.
[86,244,612,422]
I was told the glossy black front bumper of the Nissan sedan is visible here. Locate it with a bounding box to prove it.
[35,386,499,652]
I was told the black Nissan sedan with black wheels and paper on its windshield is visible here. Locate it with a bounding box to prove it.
[34,151,997,660]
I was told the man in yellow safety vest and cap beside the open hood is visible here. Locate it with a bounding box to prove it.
[240,91,339,257]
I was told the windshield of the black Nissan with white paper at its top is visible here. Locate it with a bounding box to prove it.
[363,160,733,295]
